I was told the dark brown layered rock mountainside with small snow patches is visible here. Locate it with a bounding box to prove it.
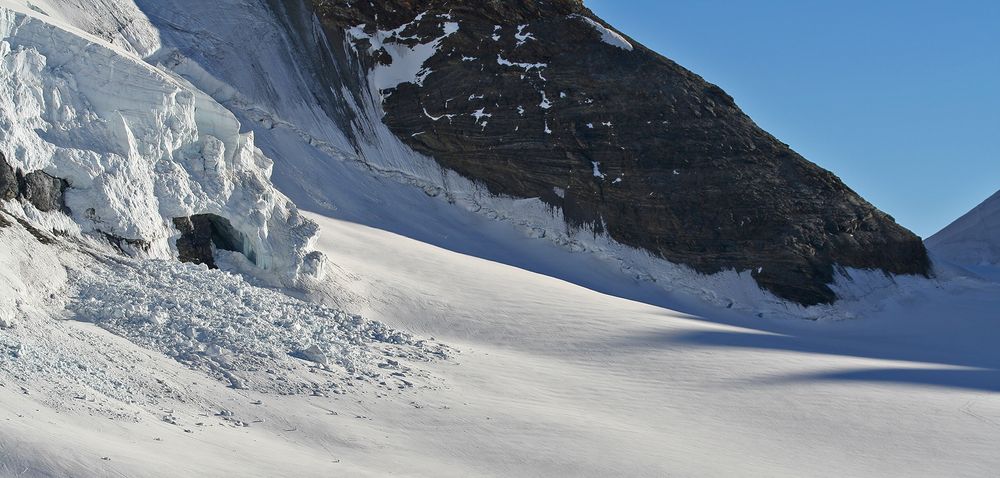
[312,0,930,305]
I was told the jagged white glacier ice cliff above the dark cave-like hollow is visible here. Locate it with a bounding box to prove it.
[0,5,322,283]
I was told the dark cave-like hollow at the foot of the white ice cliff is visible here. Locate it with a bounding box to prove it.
[174,214,255,269]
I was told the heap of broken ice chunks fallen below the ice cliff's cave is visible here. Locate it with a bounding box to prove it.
[67,252,447,394]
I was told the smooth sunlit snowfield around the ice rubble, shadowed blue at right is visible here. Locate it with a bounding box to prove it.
[0,210,1000,477]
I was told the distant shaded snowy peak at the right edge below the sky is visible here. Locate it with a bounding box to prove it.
[925,192,1000,266]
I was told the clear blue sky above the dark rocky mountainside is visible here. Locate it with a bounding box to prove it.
[584,0,1000,237]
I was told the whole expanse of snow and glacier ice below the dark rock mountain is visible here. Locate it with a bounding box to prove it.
[0,0,1000,477]
